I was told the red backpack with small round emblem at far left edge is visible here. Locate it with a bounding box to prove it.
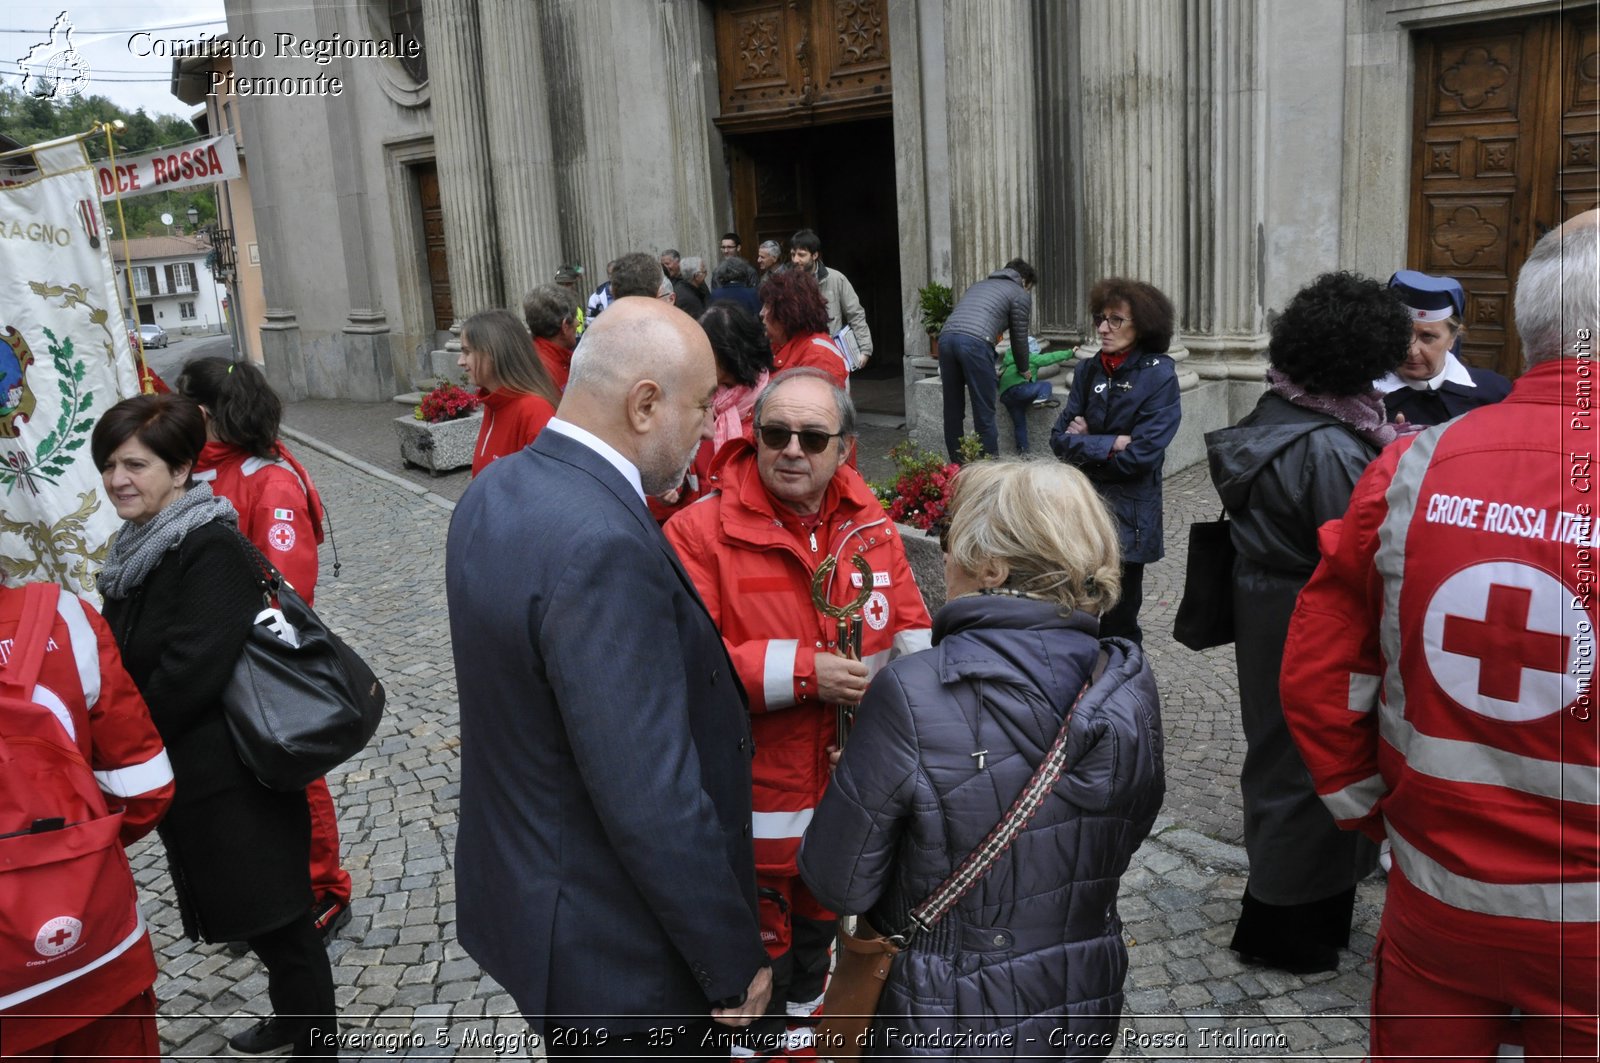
[0,583,144,1012]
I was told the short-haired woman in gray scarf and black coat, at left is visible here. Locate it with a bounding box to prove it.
[90,395,338,1057]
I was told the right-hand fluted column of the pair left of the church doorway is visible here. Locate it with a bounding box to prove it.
[473,0,563,302]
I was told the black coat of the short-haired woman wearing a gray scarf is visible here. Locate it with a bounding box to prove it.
[106,520,312,941]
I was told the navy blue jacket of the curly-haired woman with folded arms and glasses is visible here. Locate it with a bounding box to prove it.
[1050,349,1182,564]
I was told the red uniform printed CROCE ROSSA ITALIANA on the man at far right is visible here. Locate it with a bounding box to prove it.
[1282,359,1600,1058]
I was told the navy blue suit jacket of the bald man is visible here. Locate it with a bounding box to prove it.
[445,429,766,1033]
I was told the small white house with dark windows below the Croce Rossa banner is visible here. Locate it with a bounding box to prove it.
[112,235,227,336]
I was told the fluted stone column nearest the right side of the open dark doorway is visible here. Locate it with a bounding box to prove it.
[940,0,1043,296]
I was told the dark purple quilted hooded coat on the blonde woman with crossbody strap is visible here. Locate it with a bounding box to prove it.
[800,597,1165,1058]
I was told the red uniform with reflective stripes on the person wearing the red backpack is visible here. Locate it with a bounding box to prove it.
[0,589,173,1058]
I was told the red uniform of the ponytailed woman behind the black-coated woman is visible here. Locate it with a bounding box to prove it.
[194,440,350,905]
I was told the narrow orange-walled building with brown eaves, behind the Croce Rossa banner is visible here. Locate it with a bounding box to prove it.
[173,56,267,362]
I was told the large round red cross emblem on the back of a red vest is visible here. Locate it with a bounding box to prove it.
[1422,560,1594,722]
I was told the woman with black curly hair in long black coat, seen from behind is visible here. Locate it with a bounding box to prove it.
[1205,272,1411,973]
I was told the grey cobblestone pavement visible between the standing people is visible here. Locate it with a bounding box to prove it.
[131,419,1382,1060]
